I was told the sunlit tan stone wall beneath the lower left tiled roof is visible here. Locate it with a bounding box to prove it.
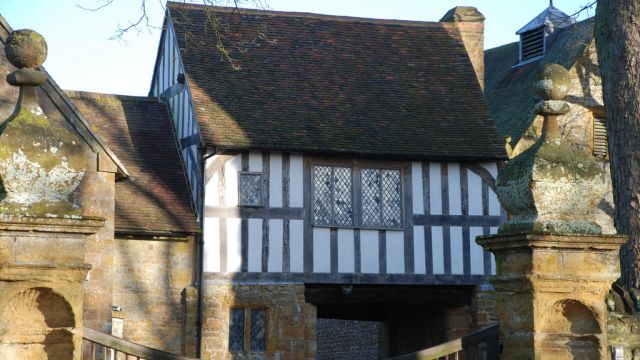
[113,235,197,356]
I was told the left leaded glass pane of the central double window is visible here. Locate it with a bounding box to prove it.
[313,166,353,226]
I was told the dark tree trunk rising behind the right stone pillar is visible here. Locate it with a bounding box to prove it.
[595,0,640,288]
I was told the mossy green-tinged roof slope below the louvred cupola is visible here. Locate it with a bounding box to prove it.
[484,18,594,144]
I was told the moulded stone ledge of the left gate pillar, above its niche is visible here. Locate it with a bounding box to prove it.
[0,216,105,234]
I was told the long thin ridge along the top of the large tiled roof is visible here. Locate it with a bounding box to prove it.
[167,1,455,27]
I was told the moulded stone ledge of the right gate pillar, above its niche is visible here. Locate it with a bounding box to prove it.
[476,234,628,251]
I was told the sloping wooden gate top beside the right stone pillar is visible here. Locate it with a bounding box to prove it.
[387,325,500,360]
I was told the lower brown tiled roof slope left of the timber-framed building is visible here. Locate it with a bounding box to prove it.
[67,91,199,233]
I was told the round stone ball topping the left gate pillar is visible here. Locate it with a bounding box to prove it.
[4,29,47,69]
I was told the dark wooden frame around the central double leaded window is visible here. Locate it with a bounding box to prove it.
[309,158,408,231]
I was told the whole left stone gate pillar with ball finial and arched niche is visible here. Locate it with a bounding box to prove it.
[0,30,104,360]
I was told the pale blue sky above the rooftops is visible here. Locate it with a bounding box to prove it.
[0,0,595,95]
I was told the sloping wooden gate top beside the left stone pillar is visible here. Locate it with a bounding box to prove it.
[82,328,196,360]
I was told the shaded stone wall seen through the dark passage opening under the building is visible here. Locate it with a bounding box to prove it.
[316,319,387,360]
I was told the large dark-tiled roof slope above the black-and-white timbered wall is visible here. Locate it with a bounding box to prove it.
[168,2,505,160]
